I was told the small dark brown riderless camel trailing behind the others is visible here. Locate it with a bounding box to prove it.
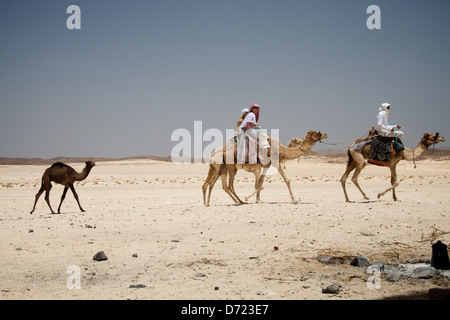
[30,161,95,214]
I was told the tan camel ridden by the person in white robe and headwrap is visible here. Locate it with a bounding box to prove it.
[341,133,445,202]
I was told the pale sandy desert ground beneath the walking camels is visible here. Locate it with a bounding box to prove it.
[0,156,450,300]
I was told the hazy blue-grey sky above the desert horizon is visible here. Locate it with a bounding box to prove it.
[0,0,450,158]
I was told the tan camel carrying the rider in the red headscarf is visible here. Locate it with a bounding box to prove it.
[202,130,328,207]
